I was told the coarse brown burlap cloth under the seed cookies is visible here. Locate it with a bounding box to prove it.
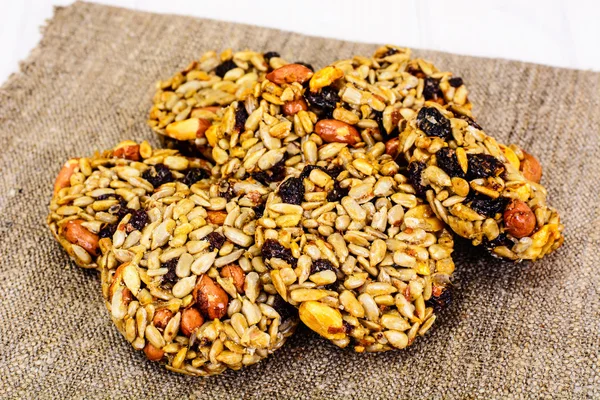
[0,3,600,399]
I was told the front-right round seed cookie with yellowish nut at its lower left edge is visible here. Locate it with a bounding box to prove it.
[256,143,454,352]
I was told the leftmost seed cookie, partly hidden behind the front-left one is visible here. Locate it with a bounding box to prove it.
[47,141,211,268]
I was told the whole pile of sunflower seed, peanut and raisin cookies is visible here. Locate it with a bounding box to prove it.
[48,46,563,376]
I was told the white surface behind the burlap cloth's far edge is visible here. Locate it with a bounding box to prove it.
[0,0,600,82]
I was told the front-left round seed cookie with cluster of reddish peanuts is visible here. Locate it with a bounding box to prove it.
[99,180,298,376]
